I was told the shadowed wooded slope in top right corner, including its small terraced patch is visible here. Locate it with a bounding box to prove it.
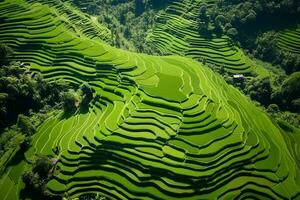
[192,0,300,74]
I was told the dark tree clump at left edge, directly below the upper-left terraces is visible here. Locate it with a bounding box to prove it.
[0,62,69,130]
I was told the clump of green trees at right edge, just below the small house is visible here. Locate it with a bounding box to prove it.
[243,74,300,128]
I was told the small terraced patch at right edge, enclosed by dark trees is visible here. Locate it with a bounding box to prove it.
[277,26,300,54]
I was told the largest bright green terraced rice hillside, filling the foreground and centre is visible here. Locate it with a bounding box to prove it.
[0,0,300,199]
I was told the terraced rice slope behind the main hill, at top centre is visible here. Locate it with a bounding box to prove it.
[149,0,255,73]
